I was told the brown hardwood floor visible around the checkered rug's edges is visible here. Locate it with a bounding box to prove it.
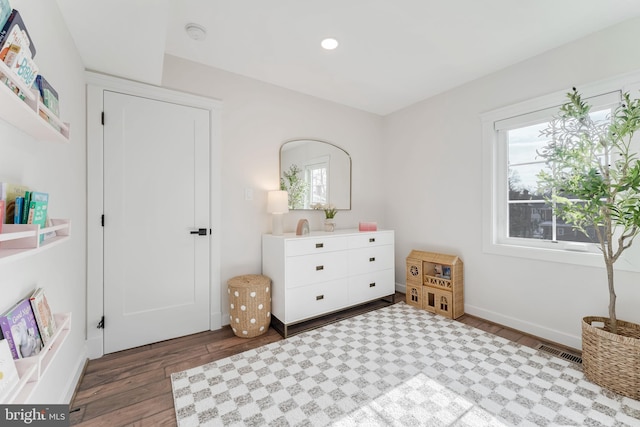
[70,293,579,427]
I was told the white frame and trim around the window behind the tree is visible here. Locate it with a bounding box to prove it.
[481,74,640,271]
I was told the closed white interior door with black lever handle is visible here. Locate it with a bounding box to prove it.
[104,91,210,353]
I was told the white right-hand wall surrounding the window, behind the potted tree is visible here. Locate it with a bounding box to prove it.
[382,19,640,348]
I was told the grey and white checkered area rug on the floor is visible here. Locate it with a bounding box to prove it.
[171,303,640,427]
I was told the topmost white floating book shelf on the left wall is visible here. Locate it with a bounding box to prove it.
[0,61,69,142]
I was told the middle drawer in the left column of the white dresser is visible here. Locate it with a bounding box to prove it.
[285,252,348,289]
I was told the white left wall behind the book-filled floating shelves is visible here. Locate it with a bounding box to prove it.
[0,0,86,403]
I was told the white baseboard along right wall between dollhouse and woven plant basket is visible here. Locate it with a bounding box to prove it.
[464,304,582,350]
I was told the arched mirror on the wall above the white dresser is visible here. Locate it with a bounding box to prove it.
[280,139,351,209]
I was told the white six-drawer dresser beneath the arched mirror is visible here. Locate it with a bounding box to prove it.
[262,229,395,338]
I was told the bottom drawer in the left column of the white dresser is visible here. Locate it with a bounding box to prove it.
[284,278,348,323]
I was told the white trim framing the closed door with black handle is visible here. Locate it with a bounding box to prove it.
[85,71,223,359]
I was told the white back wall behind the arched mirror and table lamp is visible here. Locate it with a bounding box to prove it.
[162,56,393,324]
